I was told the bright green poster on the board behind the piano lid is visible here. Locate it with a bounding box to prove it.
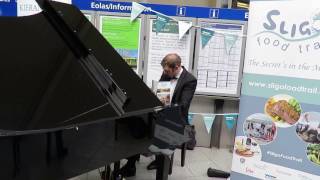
[100,16,141,72]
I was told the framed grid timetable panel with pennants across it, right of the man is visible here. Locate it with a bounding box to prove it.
[194,19,246,97]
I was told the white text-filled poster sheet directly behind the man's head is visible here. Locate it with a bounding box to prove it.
[146,20,191,87]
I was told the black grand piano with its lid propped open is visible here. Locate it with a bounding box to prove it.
[0,0,178,180]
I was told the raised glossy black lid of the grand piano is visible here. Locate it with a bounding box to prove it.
[0,0,162,136]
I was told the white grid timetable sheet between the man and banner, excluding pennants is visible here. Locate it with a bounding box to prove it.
[196,22,244,96]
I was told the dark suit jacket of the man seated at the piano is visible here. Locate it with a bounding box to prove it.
[160,66,197,124]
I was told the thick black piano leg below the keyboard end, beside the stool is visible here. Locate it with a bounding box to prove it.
[156,154,170,180]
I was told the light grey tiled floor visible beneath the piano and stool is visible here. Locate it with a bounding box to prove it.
[70,147,232,180]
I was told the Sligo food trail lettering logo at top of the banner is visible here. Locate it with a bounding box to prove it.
[255,9,320,54]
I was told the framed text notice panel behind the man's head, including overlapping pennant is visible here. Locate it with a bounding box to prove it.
[144,14,195,87]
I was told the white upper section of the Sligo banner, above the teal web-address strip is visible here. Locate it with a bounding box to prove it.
[244,0,320,79]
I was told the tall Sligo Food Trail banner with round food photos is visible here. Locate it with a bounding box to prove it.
[231,0,320,180]
